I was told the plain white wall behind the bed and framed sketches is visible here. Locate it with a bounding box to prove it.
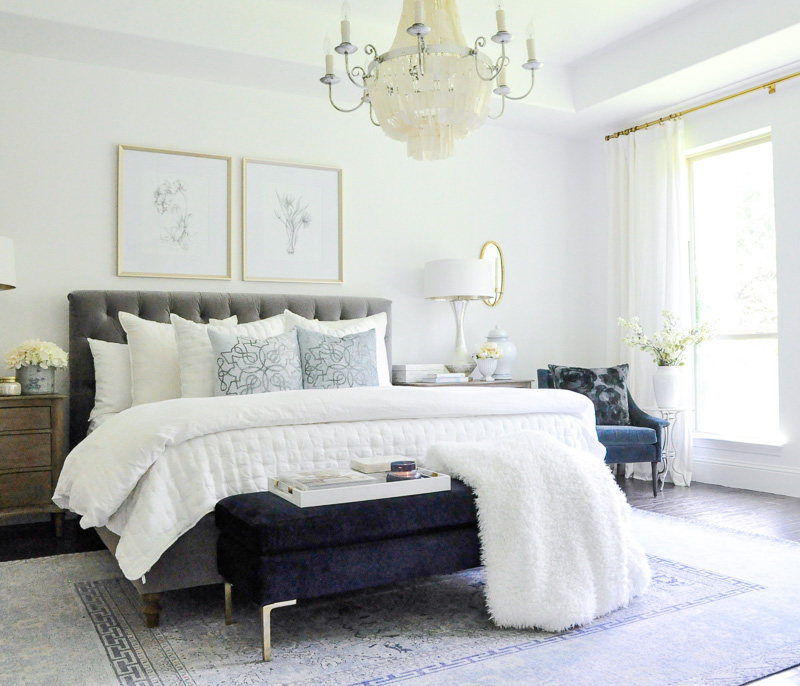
[0,53,597,398]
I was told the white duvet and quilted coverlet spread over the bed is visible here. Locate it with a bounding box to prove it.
[53,387,605,579]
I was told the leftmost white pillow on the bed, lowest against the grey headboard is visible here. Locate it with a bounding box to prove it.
[88,338,132,428]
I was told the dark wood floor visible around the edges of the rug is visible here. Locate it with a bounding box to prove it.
[0,479,800,686]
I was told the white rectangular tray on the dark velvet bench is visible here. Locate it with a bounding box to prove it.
[269,469,450,507]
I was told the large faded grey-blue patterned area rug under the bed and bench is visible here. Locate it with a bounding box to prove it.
[0,512,800,686]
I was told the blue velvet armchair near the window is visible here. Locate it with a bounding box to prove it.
[536,369,669,496]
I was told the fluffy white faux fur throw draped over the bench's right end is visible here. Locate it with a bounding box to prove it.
[425,431,650,631]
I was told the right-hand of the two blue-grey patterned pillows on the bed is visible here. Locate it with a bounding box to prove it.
[296,328,378,388]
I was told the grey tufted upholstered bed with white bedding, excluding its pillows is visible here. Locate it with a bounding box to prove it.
[61,291,605,626]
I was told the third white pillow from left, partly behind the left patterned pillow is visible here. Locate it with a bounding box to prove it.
[169,314,286,398]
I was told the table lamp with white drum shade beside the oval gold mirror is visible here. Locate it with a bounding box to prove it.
[425,259,494,373]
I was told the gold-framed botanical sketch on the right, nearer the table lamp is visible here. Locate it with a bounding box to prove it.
[242,159,342,283]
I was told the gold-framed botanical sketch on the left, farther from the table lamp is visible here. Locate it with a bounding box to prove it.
[117,145,232,279]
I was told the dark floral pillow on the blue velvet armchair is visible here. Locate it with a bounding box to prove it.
[548,364,631,426]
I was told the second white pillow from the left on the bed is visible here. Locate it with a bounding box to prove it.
[119,312,239,406]
